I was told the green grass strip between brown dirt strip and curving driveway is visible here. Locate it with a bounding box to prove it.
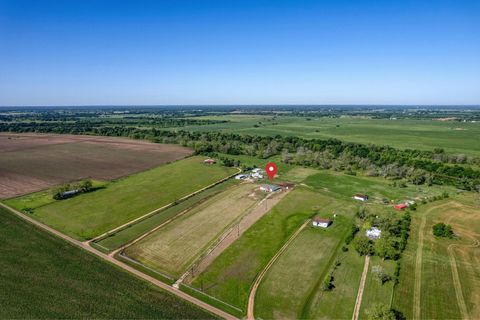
[193,187,327,310]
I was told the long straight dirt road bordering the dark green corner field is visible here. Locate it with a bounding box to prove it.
[0,203,236,319]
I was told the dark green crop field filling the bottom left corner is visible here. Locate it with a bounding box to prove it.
[0,208,213,319]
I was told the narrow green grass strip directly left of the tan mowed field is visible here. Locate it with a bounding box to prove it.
[96,179,239,251]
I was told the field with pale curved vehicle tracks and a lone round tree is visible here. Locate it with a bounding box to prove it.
[394,193,480,319]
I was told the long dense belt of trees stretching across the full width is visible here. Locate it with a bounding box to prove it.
[0,122,480,191]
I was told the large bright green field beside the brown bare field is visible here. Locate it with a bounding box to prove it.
[6,156,236,240]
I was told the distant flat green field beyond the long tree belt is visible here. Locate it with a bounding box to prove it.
[179,115,480,156]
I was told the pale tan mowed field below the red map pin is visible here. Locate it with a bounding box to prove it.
[126,184,265,277]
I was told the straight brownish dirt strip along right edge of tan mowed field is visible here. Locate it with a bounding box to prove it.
[188,189,292,281]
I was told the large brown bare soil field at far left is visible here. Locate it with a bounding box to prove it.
[0,133,192,199]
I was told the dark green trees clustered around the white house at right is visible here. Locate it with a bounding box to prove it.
[353,209,411,260]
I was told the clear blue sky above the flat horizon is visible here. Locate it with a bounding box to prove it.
[0,0,480,106]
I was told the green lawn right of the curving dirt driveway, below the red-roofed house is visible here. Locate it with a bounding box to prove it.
[255,210,355,319]
